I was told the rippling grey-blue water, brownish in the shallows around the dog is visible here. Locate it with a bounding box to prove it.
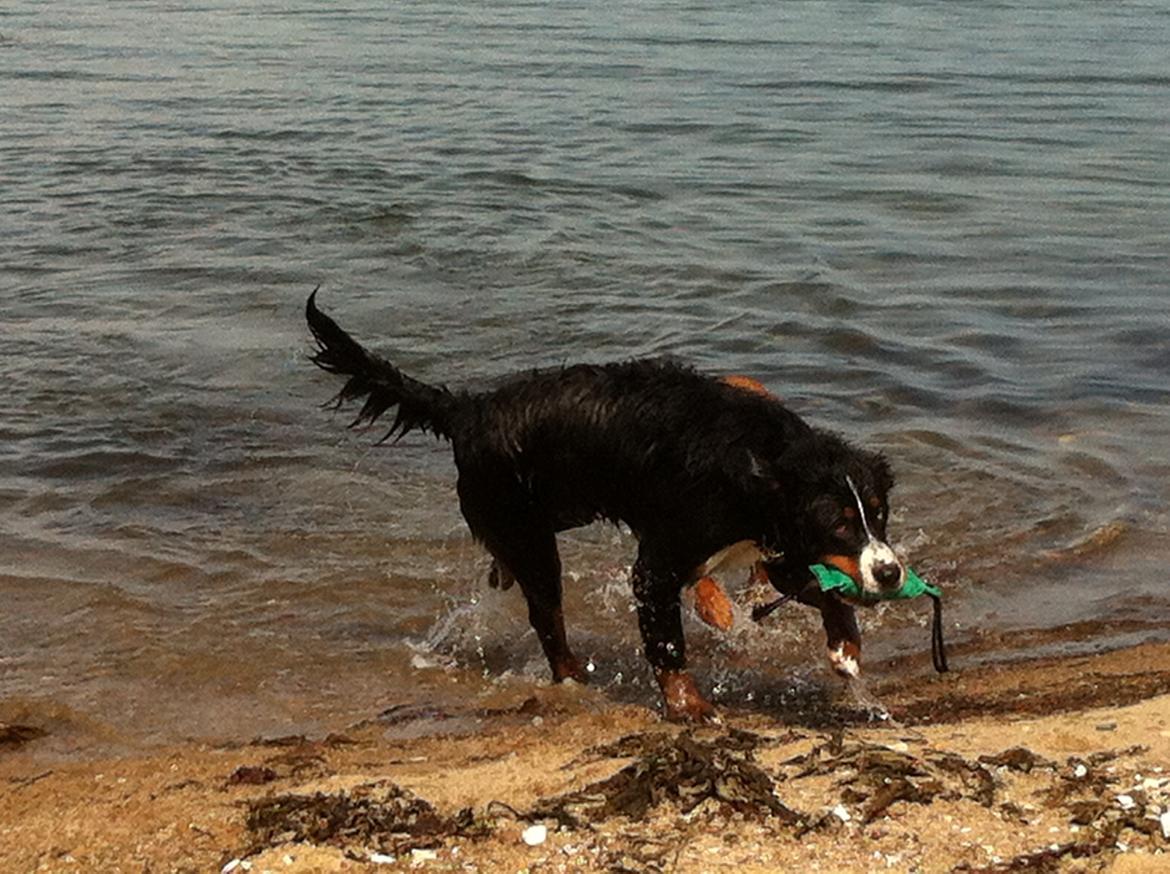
[0,0,1170,746]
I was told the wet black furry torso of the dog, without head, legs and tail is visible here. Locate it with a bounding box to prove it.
[452,359,811,534]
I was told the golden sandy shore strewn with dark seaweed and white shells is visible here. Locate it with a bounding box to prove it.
[0,644,1170,873]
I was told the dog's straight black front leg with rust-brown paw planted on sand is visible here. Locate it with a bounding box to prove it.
[633,557,715,722]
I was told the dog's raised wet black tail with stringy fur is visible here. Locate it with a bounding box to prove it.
[304,289,455,442]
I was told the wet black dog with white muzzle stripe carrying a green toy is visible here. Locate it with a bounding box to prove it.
[305,293,904,720]
